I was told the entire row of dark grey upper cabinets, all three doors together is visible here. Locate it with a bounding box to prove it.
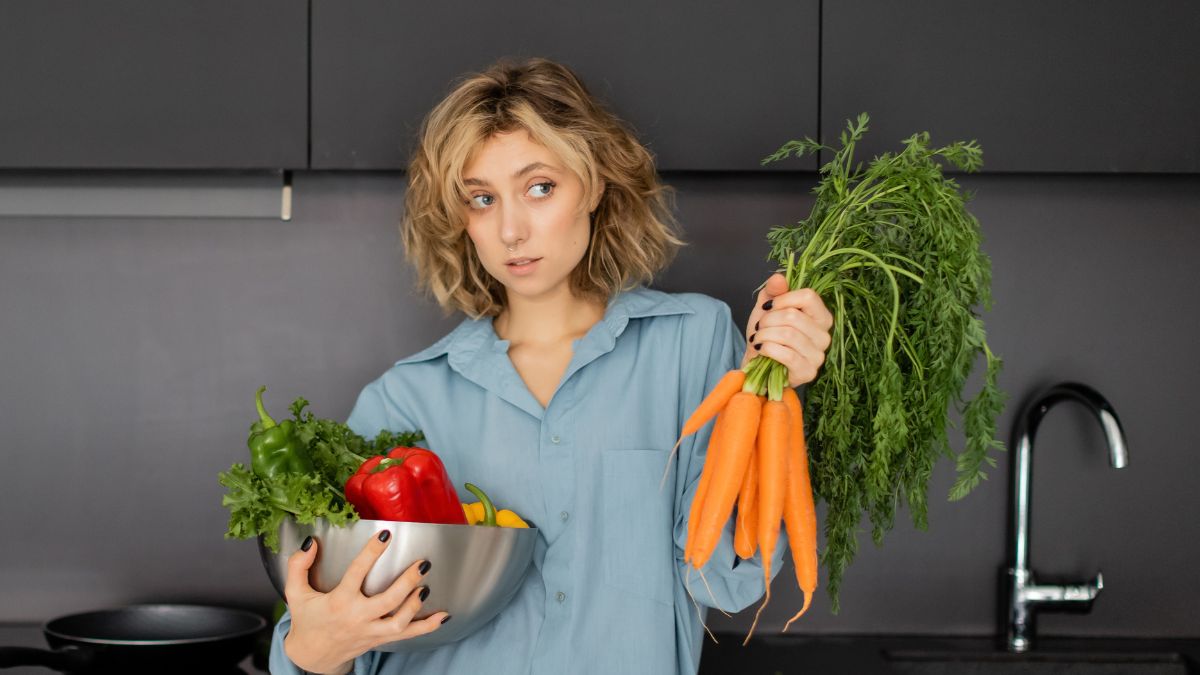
[0,0,1200,173]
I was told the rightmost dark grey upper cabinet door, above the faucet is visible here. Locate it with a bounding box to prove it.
[821,0,1200,172]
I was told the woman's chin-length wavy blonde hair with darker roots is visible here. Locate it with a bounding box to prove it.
[400,59,683,318]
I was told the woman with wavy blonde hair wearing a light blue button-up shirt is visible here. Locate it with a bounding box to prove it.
[271,60,833,675]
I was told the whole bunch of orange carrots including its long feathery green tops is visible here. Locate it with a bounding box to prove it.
[676,113,1004,641]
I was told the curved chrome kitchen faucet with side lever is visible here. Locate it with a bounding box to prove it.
[1004,382,1129,652]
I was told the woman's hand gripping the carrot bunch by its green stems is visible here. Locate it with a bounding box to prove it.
[742,274,833,387]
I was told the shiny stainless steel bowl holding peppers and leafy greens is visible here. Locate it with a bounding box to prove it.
[258,519,538,652]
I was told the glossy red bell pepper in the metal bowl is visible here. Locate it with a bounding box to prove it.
[346,447,467,525]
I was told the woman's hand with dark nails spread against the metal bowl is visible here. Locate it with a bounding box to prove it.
[283,530,450,673]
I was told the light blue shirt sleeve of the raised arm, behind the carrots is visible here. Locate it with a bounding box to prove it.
[674,296,787,613]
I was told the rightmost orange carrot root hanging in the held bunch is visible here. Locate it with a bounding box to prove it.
[784,387,817,631]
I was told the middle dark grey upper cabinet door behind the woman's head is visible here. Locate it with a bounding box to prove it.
[312,0,818,169]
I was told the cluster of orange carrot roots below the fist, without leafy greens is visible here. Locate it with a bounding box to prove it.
[676,357,817,641]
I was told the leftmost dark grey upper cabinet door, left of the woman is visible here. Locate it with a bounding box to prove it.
[0,0,308,169]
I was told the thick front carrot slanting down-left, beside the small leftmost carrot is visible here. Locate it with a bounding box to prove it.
[691,392,764,569]
